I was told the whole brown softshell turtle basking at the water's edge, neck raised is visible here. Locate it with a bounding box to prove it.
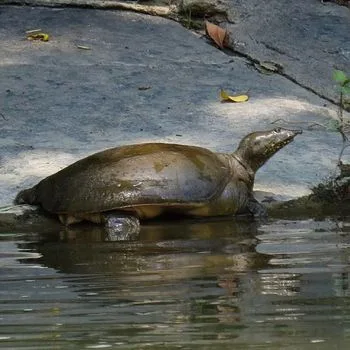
[15,128,301,237]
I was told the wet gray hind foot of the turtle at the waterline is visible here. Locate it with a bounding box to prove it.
[103,214,140,241]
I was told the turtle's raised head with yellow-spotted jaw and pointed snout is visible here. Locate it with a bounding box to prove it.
[234,128,302,173]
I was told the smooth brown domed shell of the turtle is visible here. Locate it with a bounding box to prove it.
[30,143,230,214]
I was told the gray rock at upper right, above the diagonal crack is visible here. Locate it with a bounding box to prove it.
[227,0,350,101]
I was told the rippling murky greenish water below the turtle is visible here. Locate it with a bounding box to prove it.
[0,220,350,350]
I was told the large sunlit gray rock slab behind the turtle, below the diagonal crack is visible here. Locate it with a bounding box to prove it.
[0,1,350,211]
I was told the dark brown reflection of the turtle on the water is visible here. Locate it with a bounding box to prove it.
[22,220,260,280]
